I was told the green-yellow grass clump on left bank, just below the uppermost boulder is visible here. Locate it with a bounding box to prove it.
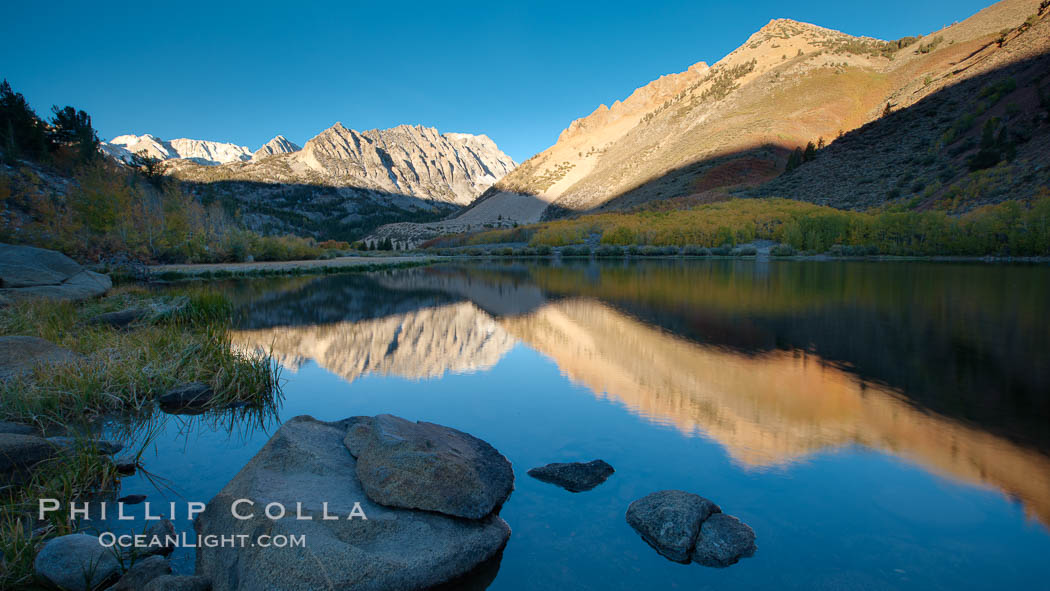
[0,291,277,428]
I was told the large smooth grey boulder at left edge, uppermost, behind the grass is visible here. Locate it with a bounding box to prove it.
[0,244,113,301]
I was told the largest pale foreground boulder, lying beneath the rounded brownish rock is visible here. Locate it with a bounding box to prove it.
[195,417,510,591]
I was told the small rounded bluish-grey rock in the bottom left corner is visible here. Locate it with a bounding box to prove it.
[33,533,121,591]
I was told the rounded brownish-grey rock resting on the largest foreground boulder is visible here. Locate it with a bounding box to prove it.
[345,415,515,520]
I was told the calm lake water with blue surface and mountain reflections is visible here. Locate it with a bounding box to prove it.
[100,260,1050,590]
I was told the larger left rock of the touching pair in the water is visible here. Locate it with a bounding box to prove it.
[627,490,721,563]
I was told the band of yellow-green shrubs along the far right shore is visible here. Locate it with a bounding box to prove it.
[440,196,1050,256]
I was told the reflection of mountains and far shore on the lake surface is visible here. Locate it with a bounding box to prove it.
[225,261,1050,525]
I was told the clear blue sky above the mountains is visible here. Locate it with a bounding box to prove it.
[0,0,991,161]
